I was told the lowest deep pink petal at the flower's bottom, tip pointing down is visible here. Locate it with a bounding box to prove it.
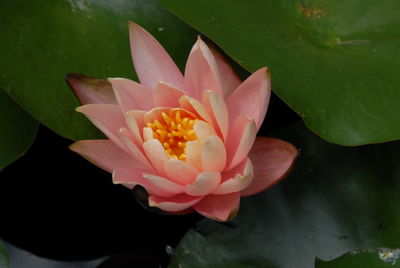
[193,192,240,221]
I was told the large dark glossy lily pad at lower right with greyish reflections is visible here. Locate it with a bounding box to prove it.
[171,124,400,268]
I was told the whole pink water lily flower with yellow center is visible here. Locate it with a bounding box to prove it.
[67,22,297,221]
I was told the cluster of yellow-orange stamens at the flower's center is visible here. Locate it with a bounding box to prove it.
[147,110,198,161]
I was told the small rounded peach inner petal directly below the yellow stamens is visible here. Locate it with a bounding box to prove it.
[164,158,199,185]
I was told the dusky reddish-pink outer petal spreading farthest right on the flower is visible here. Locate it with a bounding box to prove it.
[241,137,298,196]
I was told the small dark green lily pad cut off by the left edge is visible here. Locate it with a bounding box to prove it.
[0,89,39,171]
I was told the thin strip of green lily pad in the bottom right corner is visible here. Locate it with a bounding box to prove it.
[315,248,400,268]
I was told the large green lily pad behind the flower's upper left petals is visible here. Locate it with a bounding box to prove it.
[0,0,196,139]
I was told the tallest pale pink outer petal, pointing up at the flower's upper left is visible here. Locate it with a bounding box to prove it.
[129,21,184,89]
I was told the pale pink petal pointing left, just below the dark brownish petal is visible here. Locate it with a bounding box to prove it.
[76,104,126,148]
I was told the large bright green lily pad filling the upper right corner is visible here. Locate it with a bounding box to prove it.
[160,0,400,145]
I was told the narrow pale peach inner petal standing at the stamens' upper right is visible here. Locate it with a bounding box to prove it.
[203,90,229,140]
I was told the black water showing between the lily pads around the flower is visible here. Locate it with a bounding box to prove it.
[0,91,299,268]
